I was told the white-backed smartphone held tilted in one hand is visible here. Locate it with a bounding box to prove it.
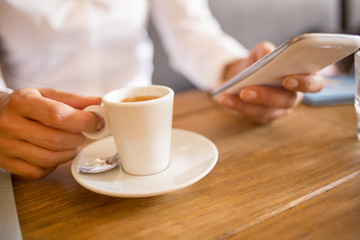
[212,33,360,99]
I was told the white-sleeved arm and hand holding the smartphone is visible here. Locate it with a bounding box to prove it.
[152,0,323,123]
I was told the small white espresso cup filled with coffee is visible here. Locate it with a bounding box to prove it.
[83,85,174,175]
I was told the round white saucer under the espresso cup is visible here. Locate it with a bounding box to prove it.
[71,129,218,197]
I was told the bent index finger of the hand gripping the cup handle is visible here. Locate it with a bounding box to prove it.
[11,89,99,132]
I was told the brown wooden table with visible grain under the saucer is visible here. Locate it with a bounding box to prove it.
[13,90,360,240]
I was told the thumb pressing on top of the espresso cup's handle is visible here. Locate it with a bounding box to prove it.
[39,89,102,109]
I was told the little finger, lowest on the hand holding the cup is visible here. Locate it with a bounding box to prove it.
[0,156,56,179]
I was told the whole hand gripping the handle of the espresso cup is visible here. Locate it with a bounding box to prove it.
[0,88,102,179]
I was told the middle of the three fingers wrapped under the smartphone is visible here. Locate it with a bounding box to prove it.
[239,86,297,109]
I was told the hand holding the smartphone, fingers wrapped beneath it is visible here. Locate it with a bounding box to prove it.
[218,42,324,123]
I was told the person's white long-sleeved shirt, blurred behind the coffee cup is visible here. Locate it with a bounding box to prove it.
[0,0,247,96]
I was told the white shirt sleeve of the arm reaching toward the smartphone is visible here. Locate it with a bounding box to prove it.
[152,0,248,90]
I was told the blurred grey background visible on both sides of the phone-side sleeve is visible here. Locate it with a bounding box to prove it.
[149,0,360,91]
